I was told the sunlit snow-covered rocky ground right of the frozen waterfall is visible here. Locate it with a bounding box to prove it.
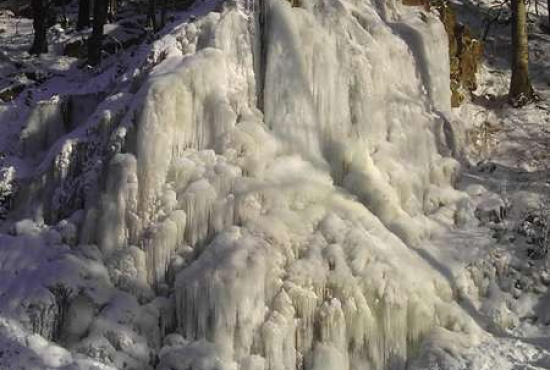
[432,1,550,369]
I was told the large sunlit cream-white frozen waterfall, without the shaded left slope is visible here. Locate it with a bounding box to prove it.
[0,0,486,370]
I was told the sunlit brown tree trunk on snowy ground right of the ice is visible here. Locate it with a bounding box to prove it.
[508,0,534,106]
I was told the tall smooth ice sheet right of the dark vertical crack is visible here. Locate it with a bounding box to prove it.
[264,2,462,249]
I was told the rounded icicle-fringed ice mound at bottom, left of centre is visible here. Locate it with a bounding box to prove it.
[176,227,276,359]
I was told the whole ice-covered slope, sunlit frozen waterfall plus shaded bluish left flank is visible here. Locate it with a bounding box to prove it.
[0,0,512,370]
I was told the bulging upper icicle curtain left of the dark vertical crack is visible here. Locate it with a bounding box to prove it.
[137,49,236,223]
